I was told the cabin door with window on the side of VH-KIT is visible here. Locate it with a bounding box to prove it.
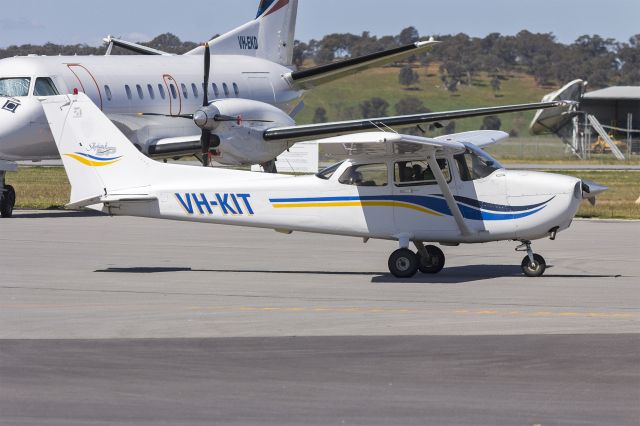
[393,158,458,235]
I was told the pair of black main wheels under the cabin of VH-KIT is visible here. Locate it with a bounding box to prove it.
[389,242,445,278]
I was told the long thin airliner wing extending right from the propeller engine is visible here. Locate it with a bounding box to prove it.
[264,102,563,143]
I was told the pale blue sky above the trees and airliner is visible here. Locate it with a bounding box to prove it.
[0,0,640,47]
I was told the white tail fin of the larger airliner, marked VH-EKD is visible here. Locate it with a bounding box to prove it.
[187,0,298,65]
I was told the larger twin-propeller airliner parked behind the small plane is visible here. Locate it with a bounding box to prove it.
[0,0,557,217]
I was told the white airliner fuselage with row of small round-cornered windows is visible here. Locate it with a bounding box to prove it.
[0,55,302,164]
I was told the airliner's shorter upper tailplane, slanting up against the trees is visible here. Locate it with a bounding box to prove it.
[284,40,439,89]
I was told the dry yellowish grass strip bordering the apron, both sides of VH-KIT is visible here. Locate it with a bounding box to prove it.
[7,167,640,219]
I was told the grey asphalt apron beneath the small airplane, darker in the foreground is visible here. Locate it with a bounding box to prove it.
[0,211,640,425]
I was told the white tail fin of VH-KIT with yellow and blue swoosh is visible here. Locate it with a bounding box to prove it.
[42,93,159,207]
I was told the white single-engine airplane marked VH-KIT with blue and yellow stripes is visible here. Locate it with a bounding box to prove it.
[43,94,606,278]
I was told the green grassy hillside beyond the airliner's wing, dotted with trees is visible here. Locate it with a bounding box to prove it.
[297,61,554,134]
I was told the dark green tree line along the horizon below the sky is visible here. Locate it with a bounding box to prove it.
[0,27,640,90]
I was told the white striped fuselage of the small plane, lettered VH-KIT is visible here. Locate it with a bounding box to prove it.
[102,157,582,243]
